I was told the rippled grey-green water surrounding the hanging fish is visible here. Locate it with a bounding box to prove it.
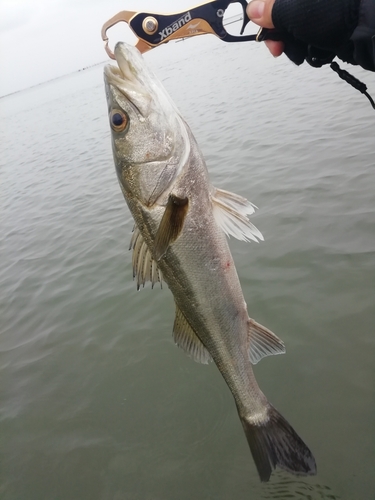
[0,37,375,500]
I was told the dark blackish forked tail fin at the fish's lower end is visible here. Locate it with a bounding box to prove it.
[240,405,316,481]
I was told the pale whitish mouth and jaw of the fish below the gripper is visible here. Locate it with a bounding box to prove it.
[104,42,152,118]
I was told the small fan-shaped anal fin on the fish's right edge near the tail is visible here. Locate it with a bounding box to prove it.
[248,318,285,365]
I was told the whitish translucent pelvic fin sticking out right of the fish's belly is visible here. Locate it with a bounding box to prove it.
[211,188,264,242]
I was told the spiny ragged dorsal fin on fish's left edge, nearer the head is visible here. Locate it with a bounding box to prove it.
[129,226,163,290]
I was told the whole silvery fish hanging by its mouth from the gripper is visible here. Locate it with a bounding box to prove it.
[104,42,316,481]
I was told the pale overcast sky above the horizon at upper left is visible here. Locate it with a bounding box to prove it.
[0,0,198,96]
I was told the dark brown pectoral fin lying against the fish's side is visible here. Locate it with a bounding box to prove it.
[154,194,189,261]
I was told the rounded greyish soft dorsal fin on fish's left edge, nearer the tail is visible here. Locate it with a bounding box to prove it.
[173,305,212,365]
